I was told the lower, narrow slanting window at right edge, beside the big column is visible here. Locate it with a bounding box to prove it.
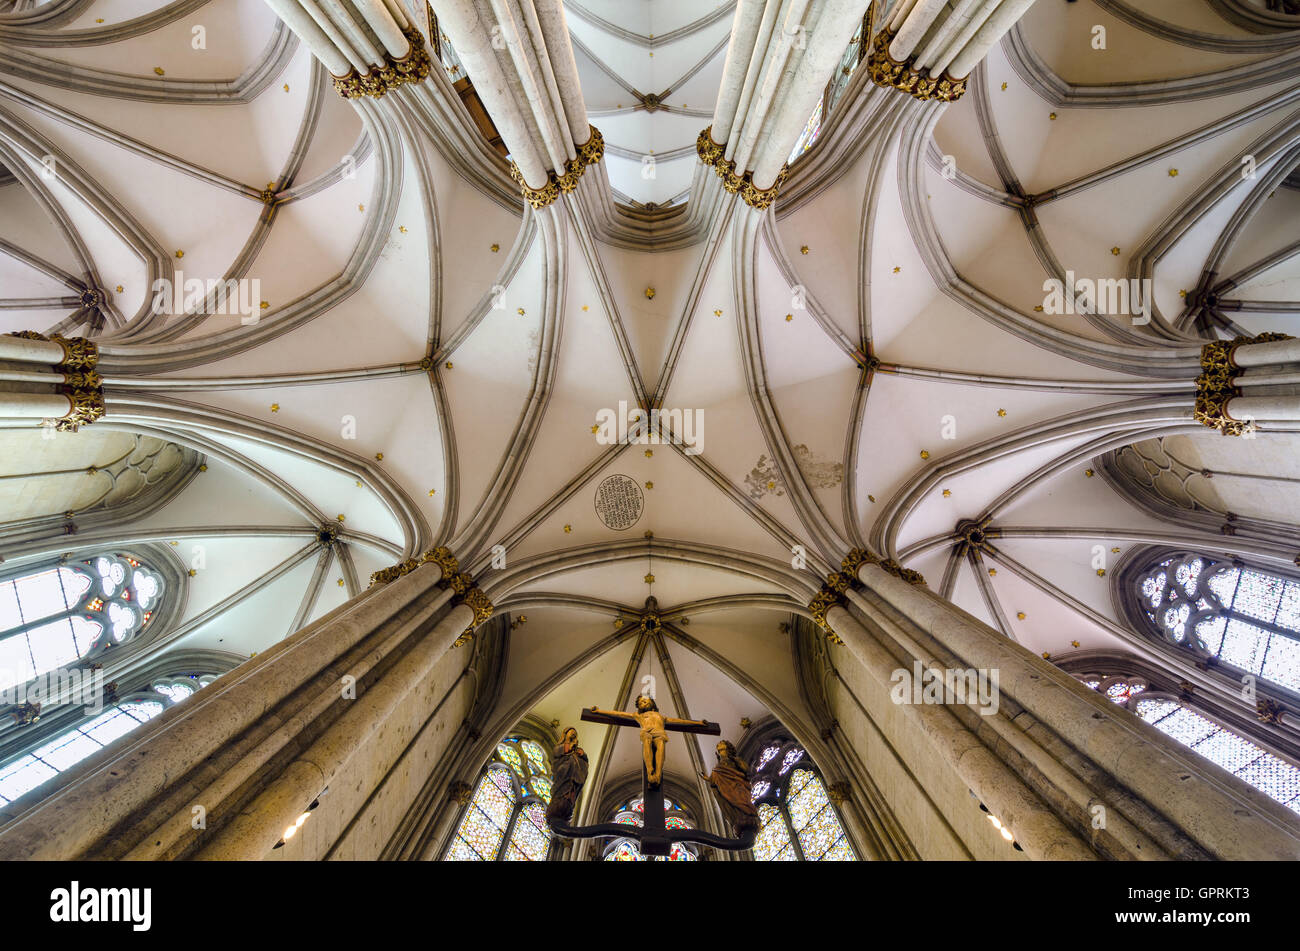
[1075,673,1300,812]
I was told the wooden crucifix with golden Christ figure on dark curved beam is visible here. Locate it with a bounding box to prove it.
[551,696,758,855]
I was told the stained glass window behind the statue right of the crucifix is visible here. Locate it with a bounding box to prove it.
[753,739,858,861]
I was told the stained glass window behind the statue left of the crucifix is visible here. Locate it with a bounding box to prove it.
[442,737,551,861]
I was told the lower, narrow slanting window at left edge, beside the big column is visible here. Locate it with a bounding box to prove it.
[0,674,217,805]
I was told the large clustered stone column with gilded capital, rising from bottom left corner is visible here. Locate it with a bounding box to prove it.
[0,548,491,860]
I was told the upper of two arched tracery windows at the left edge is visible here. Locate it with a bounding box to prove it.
[0,552,165,690]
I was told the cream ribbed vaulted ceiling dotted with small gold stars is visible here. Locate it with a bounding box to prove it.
[0,0,1300,815]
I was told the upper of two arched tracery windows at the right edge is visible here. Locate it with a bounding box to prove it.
[1136,553,1300,690]
